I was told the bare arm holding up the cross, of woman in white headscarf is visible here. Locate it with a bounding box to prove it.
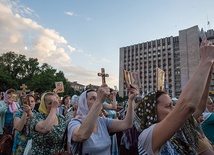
[72,84,110,142]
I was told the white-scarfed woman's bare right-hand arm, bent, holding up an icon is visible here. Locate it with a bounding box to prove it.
[109,85,139,132]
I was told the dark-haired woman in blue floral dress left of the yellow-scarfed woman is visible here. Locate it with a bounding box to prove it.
[12,95,35,155]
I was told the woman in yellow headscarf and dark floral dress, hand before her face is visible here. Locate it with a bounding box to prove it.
[30,93,66,155]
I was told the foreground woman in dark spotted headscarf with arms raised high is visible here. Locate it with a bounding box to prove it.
[137,40,214,155]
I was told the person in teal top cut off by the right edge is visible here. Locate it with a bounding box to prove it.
[201,97,214,146]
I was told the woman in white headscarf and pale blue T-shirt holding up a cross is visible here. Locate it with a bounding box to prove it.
[68,84,138,155]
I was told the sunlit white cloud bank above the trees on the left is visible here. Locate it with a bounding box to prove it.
[0,0,116,89]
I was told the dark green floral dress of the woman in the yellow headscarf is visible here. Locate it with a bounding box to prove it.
[30,113,66,155]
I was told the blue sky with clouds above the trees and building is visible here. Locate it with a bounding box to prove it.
[0,0,214,88]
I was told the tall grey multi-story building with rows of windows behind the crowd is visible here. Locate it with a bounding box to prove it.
[119,26,214,97]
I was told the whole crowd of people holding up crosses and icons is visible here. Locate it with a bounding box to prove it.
[0,39,214,155]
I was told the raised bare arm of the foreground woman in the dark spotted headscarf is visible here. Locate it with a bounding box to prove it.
[152,40,214,153]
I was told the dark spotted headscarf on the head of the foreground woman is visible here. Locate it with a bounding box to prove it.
[136,91,157,130]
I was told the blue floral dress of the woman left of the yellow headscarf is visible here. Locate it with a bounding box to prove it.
[12,111,36,155]
